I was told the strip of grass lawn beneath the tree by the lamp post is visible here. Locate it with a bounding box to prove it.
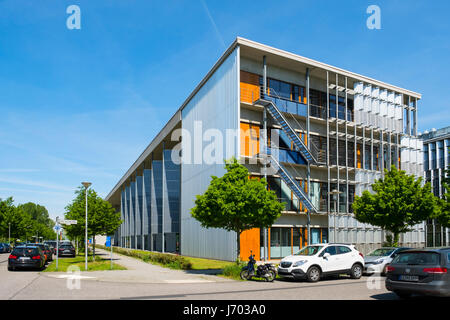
[43,255,126,272]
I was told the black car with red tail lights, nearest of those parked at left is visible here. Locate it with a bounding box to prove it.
[8,246,45,271]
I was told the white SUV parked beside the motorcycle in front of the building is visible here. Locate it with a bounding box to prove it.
[278,243,364,282]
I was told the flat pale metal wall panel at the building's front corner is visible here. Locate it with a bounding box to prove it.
[181,48,239,261]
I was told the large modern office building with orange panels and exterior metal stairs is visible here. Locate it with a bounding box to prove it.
[106,38,425,261]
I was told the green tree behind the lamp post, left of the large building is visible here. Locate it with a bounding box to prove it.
[64,187,122,259]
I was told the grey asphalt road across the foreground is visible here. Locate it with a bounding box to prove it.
[0,254,397,300]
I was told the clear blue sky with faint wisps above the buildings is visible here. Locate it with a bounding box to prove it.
[0,0,450,218]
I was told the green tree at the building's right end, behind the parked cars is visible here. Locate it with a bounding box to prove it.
[353,166,440,246]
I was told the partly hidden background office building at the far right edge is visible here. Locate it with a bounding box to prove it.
[419,126,450,247]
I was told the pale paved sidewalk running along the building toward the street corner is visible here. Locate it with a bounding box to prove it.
[41,248,233,283]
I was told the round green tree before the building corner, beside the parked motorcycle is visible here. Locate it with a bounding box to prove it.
[191,158,284,259]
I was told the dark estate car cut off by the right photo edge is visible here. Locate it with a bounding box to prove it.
[386,248,450,298]
